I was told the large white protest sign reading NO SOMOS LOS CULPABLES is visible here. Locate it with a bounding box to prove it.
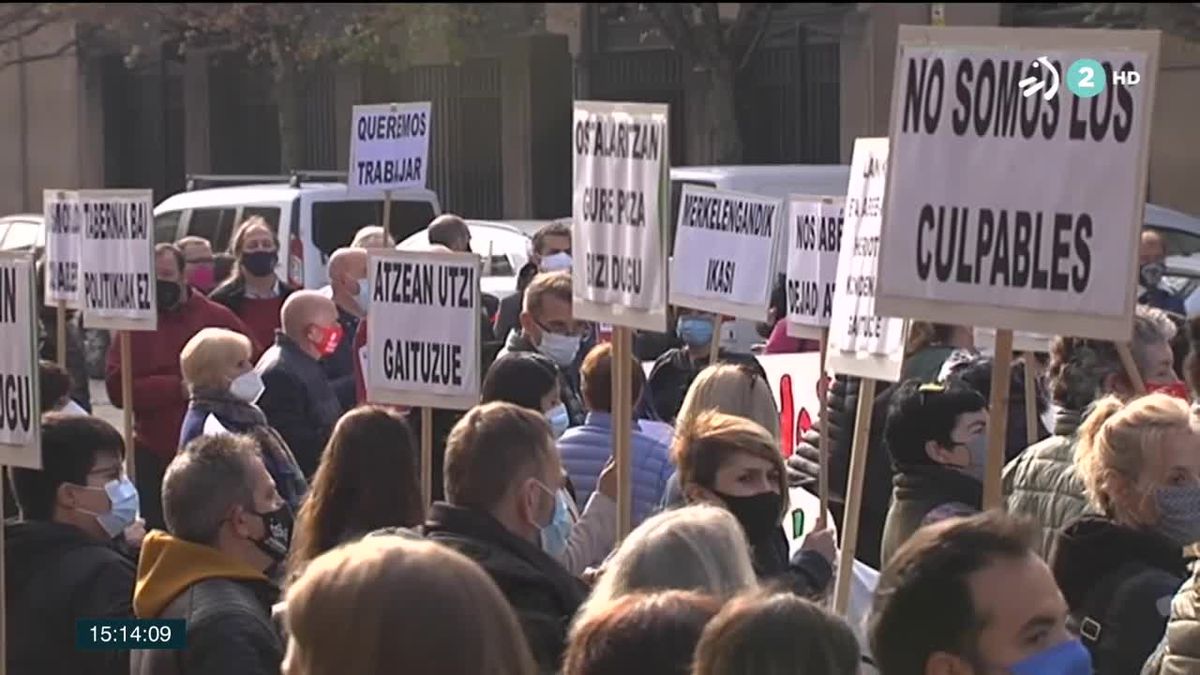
[878,26,1159,340]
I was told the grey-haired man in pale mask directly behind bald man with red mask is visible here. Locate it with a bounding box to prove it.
[320,243,371,410]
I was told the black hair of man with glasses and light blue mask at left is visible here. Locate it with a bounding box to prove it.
[8,413,125,520]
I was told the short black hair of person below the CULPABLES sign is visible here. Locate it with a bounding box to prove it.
[883,378,988,468]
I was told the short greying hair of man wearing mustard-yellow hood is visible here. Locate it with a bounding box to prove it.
[162,434,259,545]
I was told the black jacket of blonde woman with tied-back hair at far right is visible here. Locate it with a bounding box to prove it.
[1050,515,1188,675]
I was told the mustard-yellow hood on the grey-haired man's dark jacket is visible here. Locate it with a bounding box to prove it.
[133,530,268,619]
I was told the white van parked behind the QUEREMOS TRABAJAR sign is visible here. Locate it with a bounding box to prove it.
[154,172,442,288]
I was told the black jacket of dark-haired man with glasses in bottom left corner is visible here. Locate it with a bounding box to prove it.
[5,521,136,675]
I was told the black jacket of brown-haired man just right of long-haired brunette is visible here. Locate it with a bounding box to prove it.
[425,502,587,673]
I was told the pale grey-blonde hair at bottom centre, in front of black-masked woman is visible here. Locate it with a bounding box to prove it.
[576,504,758,623]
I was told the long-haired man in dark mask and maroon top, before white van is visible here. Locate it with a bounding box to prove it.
[209,216,295,355]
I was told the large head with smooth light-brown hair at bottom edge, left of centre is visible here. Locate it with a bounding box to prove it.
[283,537,536,675]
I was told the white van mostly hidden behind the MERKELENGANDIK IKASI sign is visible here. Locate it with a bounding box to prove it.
[670,165,850,354]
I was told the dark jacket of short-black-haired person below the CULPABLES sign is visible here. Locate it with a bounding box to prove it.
[880,465,983,566]
